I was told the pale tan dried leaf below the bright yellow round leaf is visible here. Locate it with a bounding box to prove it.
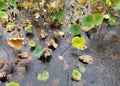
[79,55,93,64]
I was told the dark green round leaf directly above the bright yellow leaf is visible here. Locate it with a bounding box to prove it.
[70,24,82,35]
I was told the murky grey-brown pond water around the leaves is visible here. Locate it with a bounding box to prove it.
[0,1,120,86]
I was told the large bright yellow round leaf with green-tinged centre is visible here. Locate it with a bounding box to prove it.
[71,37,86,49]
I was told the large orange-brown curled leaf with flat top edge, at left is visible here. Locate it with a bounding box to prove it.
[7,38,24,50]
